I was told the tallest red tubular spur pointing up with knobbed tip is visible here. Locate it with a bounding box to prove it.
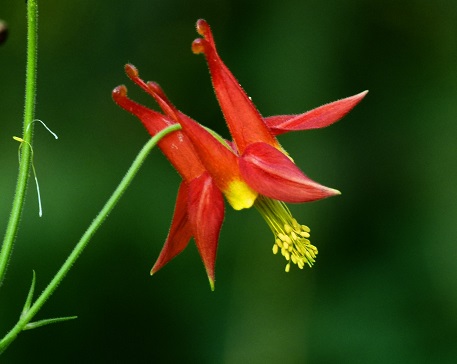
[192,19,279,153]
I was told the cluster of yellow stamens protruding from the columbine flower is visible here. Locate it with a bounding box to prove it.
[254,195,317,272]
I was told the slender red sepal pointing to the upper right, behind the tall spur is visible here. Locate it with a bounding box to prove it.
[264,91,368,135]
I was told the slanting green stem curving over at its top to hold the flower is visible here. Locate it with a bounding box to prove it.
[0,123,181,353]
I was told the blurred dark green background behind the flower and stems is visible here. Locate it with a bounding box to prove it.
[0,0,457,363]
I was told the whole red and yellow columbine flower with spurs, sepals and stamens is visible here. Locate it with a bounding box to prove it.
[113,20,366,278]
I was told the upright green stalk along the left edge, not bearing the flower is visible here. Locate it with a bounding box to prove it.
[0,0,38,286]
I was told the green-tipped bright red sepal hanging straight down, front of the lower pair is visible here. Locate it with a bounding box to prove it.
[188,173,224,290]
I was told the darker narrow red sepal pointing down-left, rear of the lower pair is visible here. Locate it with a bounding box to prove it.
[151,183,192,274]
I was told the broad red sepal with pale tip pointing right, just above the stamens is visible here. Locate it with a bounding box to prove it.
[239,143,339,202]
